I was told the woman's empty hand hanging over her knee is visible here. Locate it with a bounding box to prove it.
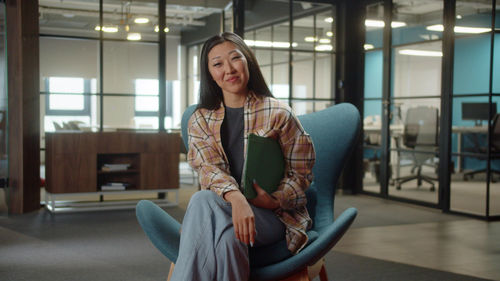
[224,190,256,246]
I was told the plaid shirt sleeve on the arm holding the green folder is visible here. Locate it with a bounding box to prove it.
[272,108,315,210]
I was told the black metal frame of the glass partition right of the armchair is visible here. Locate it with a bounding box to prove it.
[361,0,500,221]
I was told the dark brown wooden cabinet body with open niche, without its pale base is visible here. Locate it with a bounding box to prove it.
[45,132,181,193]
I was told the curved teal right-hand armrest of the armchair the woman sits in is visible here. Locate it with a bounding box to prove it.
[250,208,358,281]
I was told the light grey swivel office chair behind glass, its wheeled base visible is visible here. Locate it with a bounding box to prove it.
[394,106,439,191]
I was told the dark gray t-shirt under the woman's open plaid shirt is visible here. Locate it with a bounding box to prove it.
[220,106,244,185]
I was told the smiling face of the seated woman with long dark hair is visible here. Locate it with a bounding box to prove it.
[208,41,250,95]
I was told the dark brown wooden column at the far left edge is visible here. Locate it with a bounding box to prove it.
[6,0,40,214]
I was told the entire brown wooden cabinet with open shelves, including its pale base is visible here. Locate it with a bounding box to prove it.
[45,132,180,212]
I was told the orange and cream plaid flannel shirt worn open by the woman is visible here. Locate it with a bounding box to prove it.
[188,92,315,254]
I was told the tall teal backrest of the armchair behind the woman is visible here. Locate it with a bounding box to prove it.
[181,103,361,232]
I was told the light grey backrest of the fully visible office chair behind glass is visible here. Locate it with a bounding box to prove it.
[403,106,439,148]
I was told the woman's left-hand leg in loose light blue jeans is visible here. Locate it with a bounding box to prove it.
[171,190,249,281]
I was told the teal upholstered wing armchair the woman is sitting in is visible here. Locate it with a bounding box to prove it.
[136,103,360,281]
